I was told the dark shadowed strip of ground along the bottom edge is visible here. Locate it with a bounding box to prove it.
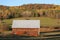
[0,35,60,40]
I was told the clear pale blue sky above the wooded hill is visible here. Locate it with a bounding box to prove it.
[0,0,60,6]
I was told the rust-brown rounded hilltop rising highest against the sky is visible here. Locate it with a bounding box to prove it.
[17,4,58,9]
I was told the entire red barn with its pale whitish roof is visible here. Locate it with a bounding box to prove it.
[12,20,40,36]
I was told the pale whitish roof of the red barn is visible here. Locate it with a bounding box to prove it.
[12,20,40,28]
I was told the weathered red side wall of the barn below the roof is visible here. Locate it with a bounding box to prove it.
[12,28,39,36]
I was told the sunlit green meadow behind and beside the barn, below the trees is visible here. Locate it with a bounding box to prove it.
[3,17,60,26]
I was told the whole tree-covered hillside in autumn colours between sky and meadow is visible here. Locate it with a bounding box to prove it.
[0,4,60,19]
